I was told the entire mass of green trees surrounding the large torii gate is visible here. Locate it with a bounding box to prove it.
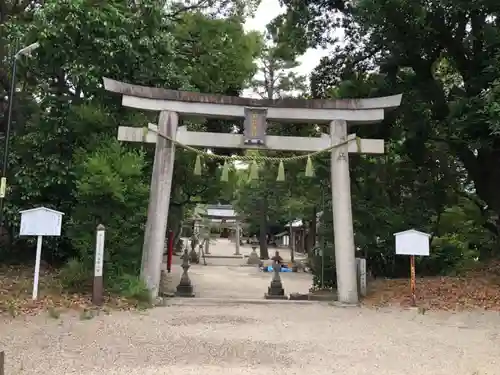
[0,0,500,296]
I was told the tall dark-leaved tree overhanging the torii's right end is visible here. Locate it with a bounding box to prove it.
[275,0,500,241]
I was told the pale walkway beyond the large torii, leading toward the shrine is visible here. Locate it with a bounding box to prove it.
[170,239,312,299]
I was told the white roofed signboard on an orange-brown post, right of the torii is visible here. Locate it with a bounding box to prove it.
[394,229,431,306]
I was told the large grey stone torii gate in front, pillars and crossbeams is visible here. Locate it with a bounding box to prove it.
[104,78,402,304]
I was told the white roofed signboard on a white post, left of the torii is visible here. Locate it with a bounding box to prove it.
[19,207,64,301]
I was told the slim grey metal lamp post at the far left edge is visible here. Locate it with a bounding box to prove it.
[0,42,40,227]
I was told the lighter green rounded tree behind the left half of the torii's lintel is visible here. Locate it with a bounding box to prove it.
[169,13,261,238]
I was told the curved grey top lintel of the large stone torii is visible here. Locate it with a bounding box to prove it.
[103,78,402,123]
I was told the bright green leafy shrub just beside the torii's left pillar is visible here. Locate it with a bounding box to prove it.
[68,138,150,287]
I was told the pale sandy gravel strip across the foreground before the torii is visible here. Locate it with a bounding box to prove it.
[0,300,500,375]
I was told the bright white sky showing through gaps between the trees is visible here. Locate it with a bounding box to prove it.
[243,0,328,97]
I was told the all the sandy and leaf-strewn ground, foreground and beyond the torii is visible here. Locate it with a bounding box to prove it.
[0,242,500,375]
